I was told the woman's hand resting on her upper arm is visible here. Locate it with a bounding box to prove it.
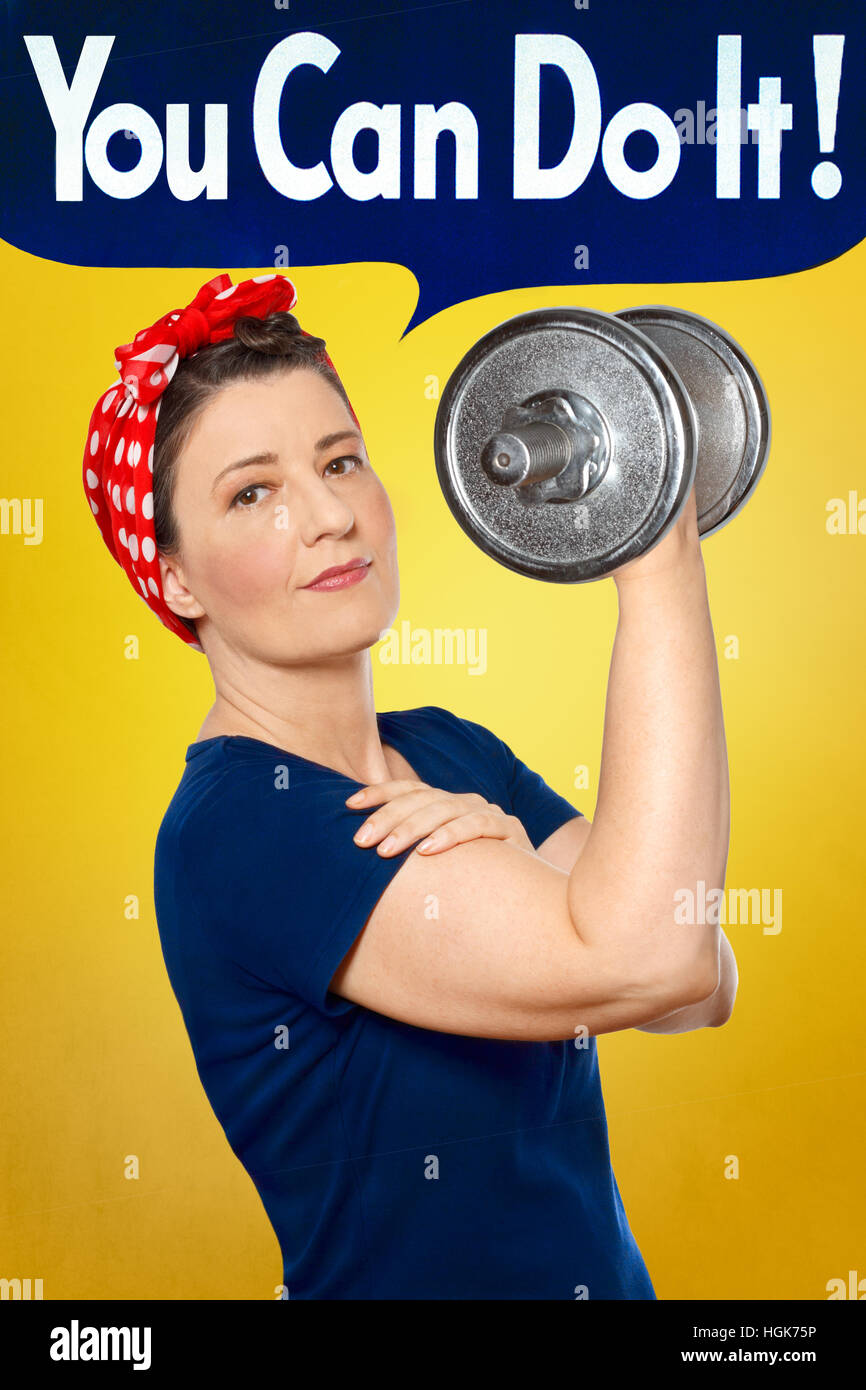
[346,781,535,856]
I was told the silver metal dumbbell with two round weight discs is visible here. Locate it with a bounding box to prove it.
[434,304,770,584]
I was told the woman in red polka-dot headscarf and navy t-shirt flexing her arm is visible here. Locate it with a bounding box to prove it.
[85,275,735,1300]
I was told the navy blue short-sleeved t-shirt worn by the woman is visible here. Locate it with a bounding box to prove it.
[154,705,656,1300]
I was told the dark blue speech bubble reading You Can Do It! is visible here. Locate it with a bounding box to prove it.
[0,0,866,332]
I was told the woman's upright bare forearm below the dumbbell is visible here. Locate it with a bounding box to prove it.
[569,523,730,1001]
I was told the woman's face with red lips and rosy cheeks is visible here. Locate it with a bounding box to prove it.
[160,367,399,662]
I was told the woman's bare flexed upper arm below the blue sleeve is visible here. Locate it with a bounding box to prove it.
[331,822,684,1041]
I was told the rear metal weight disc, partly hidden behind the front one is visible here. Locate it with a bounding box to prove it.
[617,304,770,535]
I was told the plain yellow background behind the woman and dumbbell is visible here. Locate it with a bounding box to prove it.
[0,233,866,1300]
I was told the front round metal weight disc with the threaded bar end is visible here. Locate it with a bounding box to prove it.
[434,304,696,584]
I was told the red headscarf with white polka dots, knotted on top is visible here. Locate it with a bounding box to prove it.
[83,274,357,652]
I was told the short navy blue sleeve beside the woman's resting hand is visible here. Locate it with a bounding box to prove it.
[174,767,414,1015]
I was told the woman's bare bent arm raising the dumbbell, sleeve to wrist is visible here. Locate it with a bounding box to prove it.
[331,492,730,1040]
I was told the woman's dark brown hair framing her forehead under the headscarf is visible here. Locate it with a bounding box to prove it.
[153,310,352,635]
